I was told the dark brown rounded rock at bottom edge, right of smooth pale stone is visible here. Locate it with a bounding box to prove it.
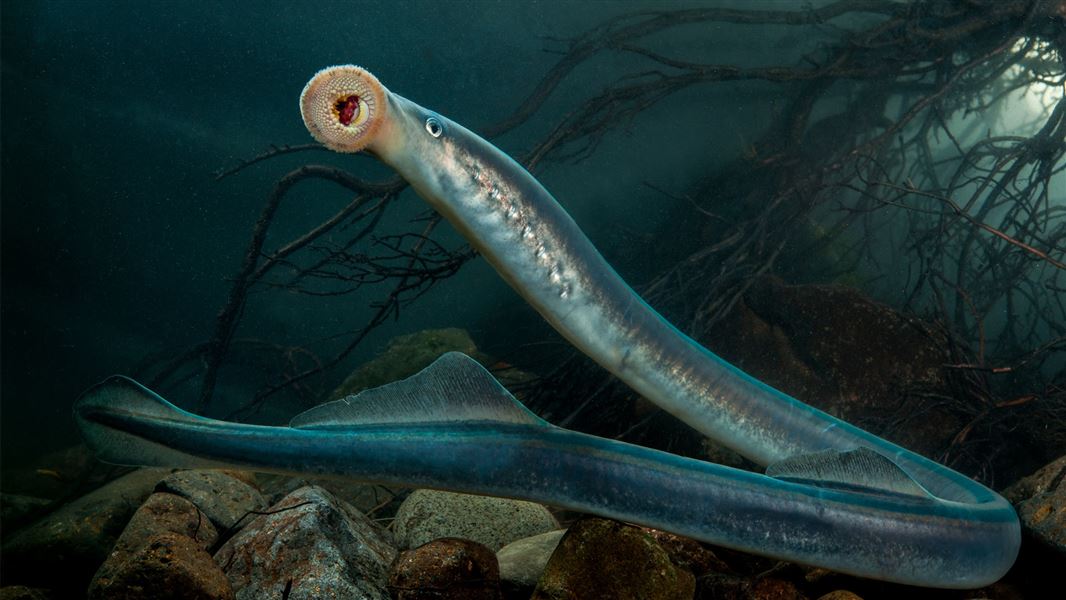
[532,518,696,600]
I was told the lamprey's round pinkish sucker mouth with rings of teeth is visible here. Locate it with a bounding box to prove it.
[300,65,388,152]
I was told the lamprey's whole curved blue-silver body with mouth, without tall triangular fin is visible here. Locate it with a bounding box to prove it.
[70,66,1020,587]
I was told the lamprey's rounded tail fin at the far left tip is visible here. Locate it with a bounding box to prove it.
[74,375,225,469]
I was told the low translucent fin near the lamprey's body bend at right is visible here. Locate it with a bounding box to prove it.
[766,448,933,499]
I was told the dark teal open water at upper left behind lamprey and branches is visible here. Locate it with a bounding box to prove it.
[0,0,793,464]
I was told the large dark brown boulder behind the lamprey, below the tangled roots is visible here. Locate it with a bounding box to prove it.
[708,276,966,455]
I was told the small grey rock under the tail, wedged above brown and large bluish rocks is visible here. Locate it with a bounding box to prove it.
[156,471,267,531]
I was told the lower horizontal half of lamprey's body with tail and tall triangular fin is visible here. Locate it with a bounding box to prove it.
[75,353,1017,587]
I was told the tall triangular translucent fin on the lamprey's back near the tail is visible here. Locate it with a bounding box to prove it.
[289,352,549,429]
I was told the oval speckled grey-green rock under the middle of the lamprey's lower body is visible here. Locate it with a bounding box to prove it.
[392,489,559,552]
